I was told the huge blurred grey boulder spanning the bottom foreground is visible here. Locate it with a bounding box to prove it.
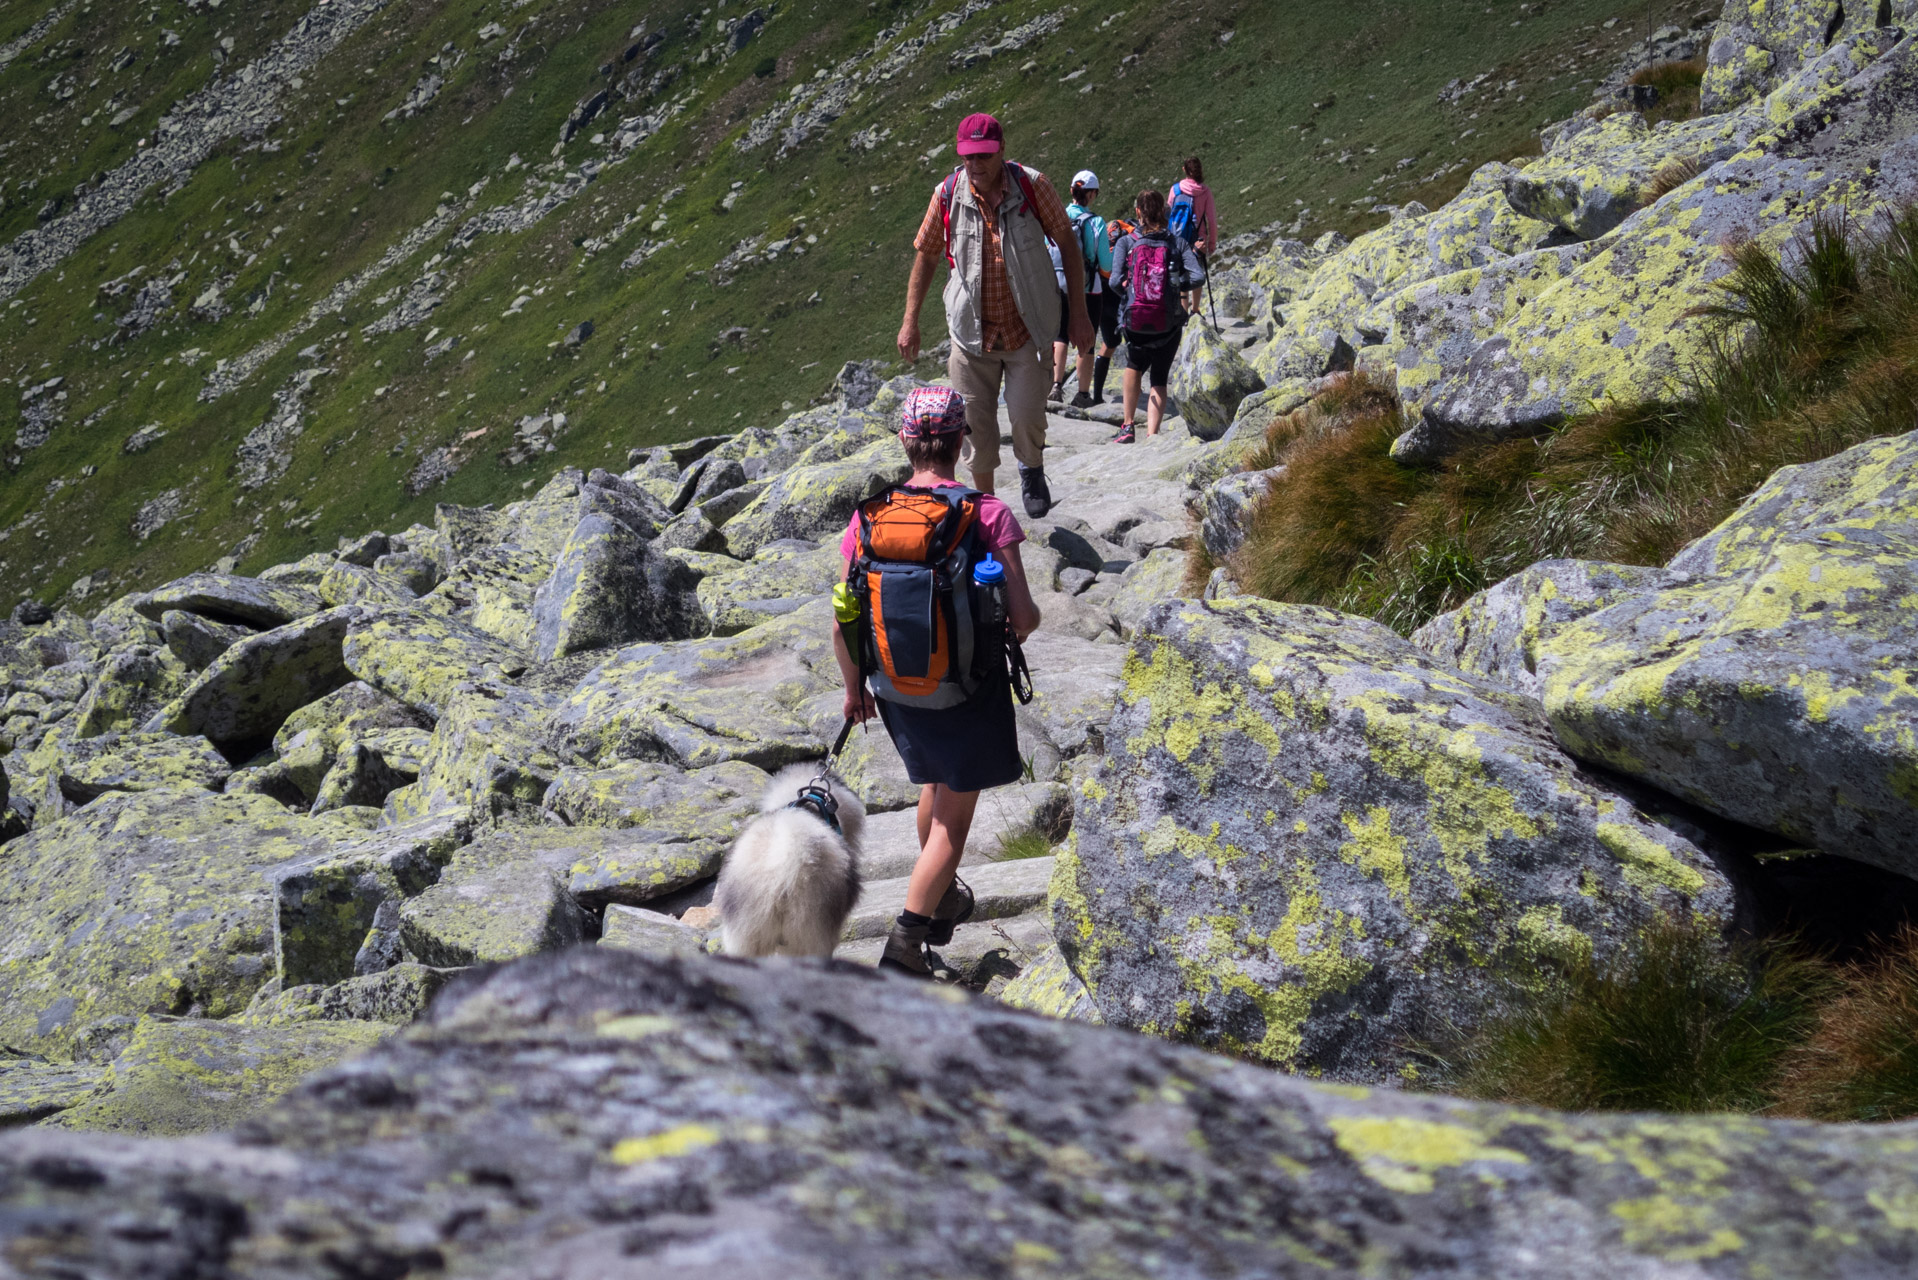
[0,948,1918,1280]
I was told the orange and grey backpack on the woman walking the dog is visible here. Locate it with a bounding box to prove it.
[863,486,1003,708]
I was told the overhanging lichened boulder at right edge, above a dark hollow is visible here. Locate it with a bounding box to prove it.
[1538,432,1918,875]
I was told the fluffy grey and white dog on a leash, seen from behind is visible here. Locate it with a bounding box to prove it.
[713,764,865,956]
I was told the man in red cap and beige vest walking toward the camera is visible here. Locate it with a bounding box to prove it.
[900,111,1091,518]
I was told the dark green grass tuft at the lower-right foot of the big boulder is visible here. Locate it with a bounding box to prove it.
[1429,919,1834,1111]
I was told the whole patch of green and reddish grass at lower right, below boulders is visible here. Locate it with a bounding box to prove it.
[1421,919,1918,1121]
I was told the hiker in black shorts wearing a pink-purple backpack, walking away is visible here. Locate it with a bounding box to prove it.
[1112,192,1205,445]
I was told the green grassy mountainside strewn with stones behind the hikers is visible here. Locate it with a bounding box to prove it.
[0,0,1690,604]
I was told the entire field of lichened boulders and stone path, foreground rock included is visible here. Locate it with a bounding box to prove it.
[0,0,1918,1280]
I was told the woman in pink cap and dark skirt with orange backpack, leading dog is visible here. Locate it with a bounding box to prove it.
[832,388,1040,977]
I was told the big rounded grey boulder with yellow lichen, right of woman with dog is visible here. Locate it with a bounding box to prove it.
[1053,599,1734,1082]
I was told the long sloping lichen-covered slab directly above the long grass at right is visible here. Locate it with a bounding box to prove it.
[1425,38,1918,450]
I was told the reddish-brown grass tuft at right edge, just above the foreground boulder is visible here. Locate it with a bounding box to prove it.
[1778,927,1918,1121]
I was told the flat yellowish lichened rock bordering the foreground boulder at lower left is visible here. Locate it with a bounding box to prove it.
[48,1017,393,1134]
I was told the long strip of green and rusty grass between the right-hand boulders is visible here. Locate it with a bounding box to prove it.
[1231,211,1918,631]
